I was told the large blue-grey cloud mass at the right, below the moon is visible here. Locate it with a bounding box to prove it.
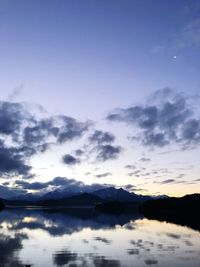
[107,88,200,149]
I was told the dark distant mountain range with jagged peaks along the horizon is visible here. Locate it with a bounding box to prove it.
[1,187,167,206]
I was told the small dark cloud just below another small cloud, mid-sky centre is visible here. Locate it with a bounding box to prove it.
[96,145,122,162]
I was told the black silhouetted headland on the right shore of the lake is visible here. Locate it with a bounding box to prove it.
[140,194,200,230]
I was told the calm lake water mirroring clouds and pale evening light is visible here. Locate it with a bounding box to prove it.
[0,209,200,267]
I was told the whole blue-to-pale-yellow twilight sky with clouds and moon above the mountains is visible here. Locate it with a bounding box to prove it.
[0,0,200,197]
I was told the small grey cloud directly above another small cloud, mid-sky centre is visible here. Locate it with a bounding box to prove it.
[89,130,115,145]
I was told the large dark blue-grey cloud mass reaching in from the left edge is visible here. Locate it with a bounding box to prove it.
[0,101,91,178]
